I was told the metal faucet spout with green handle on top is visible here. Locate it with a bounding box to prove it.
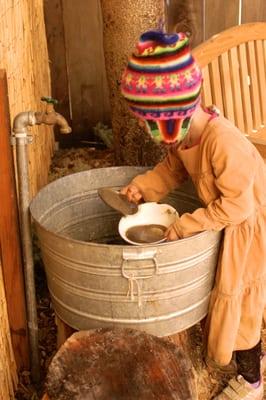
[35,97,72,134]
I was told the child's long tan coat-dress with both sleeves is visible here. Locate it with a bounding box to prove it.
[134,117,266,365]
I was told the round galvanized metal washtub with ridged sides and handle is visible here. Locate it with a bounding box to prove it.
[30,167,221,336]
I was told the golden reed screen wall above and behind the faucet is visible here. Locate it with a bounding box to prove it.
[0,0,53,194]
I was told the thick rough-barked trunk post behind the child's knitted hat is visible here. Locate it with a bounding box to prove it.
[101,0,165,165]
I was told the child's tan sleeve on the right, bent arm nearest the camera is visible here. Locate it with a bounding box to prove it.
[174,134,257,238]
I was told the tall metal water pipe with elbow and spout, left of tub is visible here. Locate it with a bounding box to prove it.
[12,107,71,382]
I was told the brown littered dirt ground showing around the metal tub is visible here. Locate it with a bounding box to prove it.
[16,147,266,400]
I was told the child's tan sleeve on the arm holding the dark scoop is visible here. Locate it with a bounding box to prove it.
[132,148,188,201]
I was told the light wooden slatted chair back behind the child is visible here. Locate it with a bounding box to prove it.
[193,22,266,158]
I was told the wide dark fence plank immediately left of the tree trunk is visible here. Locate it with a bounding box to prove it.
[62,0,109,134]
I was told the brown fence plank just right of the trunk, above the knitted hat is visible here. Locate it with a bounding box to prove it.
[166,0,204,48]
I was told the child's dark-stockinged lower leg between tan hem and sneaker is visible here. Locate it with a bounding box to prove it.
[235,341,261,383]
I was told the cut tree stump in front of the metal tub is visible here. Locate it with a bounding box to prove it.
[44,329,197,400]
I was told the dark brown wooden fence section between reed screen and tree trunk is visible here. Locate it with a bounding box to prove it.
[44,0,110,139]
